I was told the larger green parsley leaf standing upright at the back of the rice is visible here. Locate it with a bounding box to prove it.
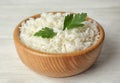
[63,13,87,30]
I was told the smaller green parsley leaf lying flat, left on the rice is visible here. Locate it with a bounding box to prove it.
[34,27,57,38]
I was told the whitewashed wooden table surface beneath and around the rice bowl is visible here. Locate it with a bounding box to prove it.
[0,0,120,83]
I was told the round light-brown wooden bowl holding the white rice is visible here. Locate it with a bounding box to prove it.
[14,12,105,77]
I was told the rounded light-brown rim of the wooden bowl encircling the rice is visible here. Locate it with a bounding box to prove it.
[13,12,105,57]
